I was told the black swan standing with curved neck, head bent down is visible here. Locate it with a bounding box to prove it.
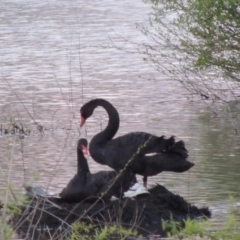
[80,99,194,187]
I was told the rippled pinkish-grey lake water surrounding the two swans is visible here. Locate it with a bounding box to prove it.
[0,0,240,237]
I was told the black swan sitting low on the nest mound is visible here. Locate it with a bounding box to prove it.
[59,138,136,203]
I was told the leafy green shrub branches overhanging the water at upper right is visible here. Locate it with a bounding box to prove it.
[141,0,240,101]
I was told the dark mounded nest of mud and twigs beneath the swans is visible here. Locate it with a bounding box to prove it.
[10,185,211,239]
